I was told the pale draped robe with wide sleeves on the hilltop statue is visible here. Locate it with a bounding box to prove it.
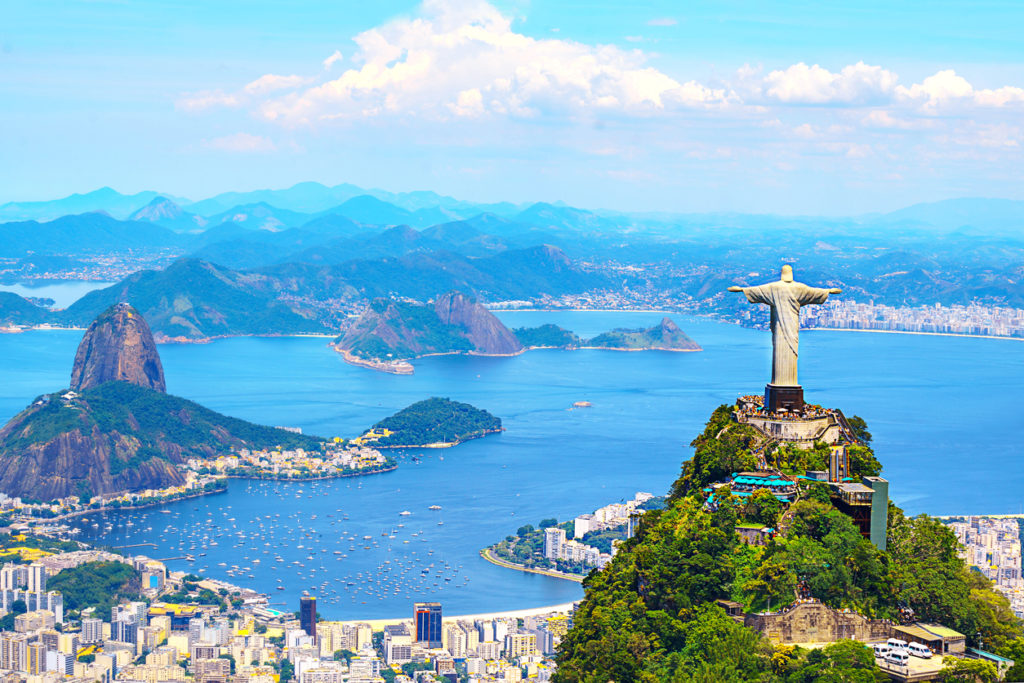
[743,280,828,386]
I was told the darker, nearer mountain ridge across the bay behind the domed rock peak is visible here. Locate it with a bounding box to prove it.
[0,240,607,341]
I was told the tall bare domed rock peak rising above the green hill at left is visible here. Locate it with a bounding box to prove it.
[71,303,167,391]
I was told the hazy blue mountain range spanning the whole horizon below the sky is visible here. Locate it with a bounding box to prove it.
[0,182,1024,313]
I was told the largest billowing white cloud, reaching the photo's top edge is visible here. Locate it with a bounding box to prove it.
[262,0,730,125]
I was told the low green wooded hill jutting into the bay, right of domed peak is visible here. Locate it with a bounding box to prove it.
[352,396,502,449]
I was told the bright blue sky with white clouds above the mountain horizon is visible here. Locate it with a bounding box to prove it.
[0,0,1024,215]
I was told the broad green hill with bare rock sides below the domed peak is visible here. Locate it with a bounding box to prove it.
[0,382,323,501]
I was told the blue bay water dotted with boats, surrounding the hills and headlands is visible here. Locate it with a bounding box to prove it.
[0,312,1024,618]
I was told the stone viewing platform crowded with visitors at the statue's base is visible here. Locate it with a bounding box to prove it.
[733,395,856,449]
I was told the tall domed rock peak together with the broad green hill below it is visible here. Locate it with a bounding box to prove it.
[0,303,352,502]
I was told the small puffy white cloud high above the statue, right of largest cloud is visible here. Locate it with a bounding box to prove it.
[761,61,898,104]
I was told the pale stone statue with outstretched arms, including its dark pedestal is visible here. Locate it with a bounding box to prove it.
[729,265,842,413]
